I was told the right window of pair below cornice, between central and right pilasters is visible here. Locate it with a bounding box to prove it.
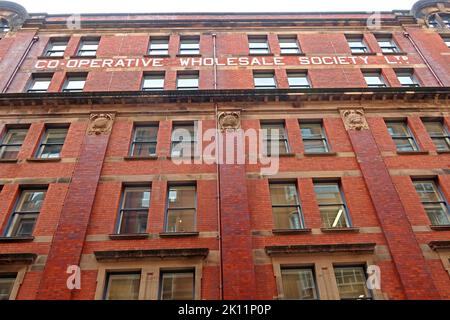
[300,122,330,153]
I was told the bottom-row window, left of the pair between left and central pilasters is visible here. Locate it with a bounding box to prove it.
[104,272,141,300]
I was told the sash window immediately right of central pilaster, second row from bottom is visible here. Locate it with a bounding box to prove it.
[269,183,304,230]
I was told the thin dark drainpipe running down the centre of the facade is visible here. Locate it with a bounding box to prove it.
[212,33,223,300]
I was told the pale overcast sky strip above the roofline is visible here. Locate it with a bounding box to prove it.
[12,0,417,13]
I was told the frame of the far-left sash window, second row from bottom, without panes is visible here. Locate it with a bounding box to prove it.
[2,186,48,239]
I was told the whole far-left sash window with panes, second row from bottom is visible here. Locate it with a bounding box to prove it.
[6,190,46,237]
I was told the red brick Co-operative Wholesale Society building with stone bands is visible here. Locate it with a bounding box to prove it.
[0,1,450,300]
